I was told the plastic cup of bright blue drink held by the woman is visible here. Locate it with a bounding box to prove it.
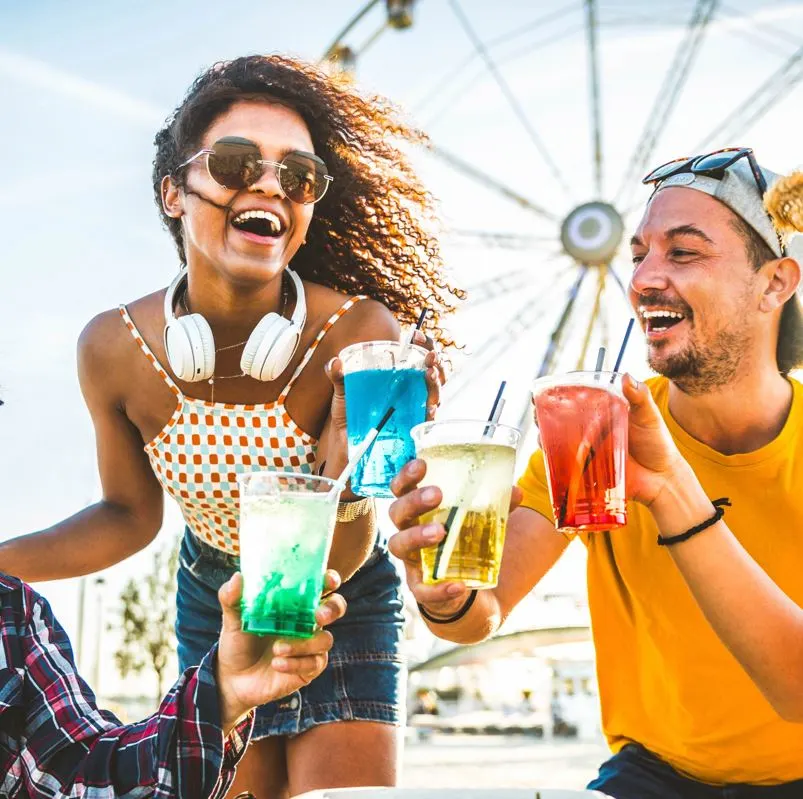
[340,341,427,497]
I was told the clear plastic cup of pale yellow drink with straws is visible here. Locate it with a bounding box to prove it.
[412,420,519,588]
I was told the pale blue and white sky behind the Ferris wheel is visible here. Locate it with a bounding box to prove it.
[0,0,803,692]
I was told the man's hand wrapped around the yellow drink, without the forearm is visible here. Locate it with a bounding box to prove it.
[388,460,521,618]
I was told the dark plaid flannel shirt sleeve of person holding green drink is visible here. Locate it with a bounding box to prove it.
[0,574,253,799]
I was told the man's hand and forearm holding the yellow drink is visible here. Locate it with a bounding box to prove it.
[390,460,568,644]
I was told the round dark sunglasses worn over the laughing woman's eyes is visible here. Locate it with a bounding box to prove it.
[176,136,334,205]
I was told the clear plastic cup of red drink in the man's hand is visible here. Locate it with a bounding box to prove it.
[533,372,628,532]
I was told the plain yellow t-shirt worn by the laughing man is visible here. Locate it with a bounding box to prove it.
[519,378,803,785]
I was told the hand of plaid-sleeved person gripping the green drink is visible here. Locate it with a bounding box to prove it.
[216,570,346,735]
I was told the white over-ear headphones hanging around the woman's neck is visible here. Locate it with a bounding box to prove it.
[164,267,307,383]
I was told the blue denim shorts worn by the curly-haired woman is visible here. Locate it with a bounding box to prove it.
[176,530,406,740]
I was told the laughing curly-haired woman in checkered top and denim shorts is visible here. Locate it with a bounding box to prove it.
[0,56,462,799]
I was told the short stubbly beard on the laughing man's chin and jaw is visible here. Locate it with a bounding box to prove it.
[648,326,749,396]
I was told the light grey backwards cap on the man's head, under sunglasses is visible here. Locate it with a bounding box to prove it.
[645,153,803,266]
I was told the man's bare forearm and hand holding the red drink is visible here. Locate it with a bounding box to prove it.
[623,378,803,722]
